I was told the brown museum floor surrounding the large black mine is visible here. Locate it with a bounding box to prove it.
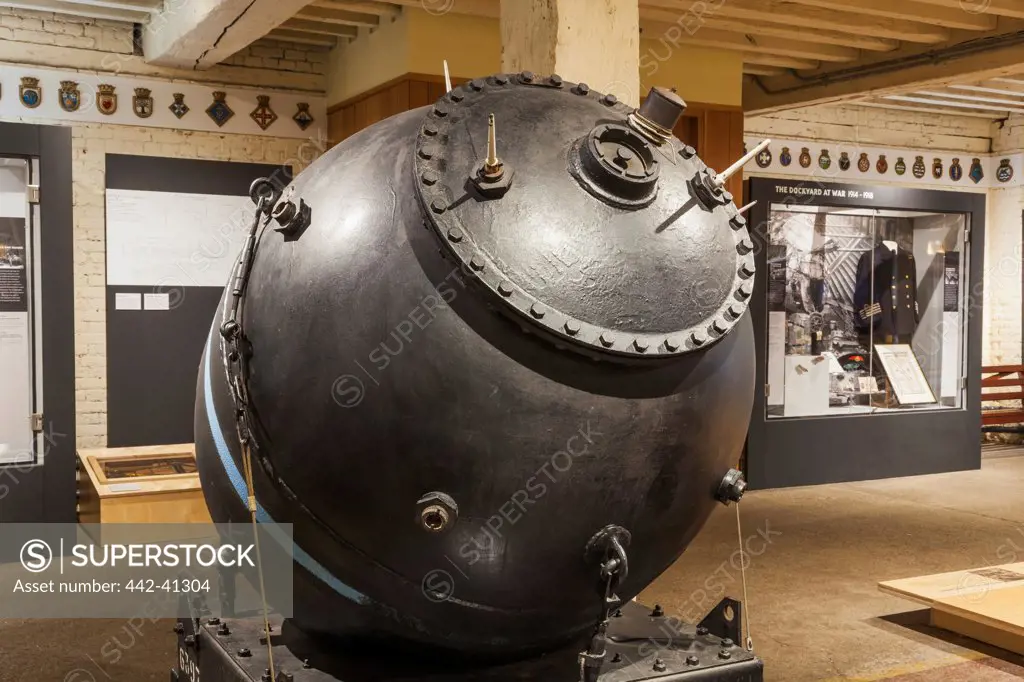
[0,451,1024,682]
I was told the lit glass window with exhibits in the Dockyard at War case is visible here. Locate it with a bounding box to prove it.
[765,204,968,419]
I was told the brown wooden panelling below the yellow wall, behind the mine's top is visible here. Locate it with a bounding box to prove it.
[328,74,743,199]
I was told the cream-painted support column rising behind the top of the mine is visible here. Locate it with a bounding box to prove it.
[501,0,642,106]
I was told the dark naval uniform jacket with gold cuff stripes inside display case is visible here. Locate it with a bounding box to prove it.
[853,244,921,343]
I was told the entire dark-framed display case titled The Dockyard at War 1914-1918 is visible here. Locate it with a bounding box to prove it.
[743,177,985,488]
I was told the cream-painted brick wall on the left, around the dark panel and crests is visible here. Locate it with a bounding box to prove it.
[0,7,327,447]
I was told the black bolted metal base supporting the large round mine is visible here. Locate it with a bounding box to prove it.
[170,599,764,682]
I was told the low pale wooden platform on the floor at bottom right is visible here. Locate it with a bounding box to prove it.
[879,563,1024,654]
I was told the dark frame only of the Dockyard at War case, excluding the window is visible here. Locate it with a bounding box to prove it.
[744,177,985,488]
